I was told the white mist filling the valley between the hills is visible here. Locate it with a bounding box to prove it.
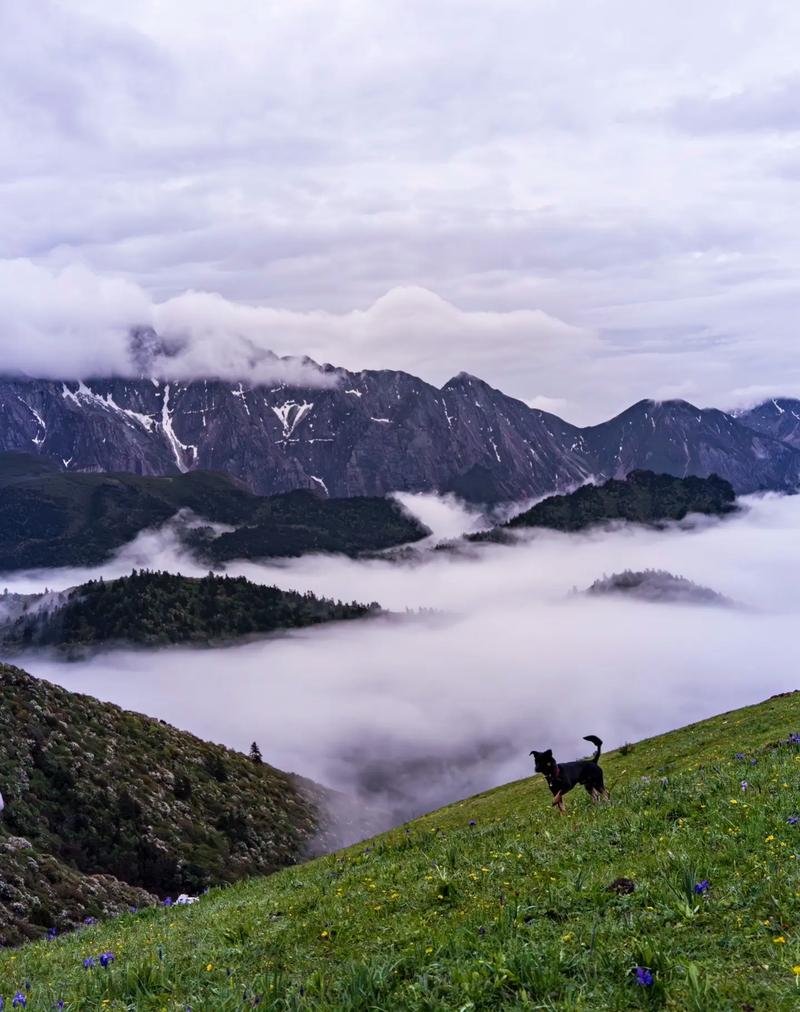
[0,495,800,822]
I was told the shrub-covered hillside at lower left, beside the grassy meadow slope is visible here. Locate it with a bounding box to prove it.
[0,665,333,943]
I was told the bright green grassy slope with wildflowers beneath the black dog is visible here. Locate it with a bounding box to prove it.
[0,692,800,1012]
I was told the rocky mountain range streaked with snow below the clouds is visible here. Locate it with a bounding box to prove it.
[0,366,800,503]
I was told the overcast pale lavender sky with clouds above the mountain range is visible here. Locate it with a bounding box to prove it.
[0,0,800,422]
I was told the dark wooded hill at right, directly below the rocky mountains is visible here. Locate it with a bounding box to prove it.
[467,471,736,541]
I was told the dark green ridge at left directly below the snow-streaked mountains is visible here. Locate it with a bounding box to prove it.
[0,452,429,572]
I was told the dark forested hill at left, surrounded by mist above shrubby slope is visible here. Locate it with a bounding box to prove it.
[0,570,379,652]
